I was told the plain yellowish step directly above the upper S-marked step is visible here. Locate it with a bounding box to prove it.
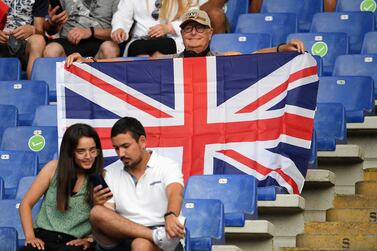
[333,195,377,208]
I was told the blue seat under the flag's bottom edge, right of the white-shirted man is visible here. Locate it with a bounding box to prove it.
[184,174,258,227]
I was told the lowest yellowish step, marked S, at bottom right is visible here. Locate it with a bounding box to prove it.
[296,234,377,250]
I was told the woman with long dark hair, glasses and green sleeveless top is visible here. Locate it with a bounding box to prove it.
[19,124,103,251]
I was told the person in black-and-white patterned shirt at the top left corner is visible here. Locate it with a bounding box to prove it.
[0,0,48,78]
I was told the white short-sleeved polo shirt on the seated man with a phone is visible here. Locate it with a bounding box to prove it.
[105,152,183,226]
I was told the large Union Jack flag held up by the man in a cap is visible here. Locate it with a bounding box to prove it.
[57,53,318,194]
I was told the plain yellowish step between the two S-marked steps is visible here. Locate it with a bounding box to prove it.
[304,221,377,234]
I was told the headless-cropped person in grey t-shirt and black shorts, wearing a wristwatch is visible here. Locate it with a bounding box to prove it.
[43,0,119,58]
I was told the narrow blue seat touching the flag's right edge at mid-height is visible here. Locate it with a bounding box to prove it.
[314,103,347,151]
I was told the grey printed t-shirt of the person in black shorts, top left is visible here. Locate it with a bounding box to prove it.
[60,0,119,38]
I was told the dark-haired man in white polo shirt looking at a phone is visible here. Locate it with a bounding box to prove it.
[90,117,184,251]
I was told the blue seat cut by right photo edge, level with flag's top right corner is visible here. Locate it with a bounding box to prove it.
[333,54,377,99]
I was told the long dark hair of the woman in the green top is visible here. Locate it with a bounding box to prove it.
[56,124,103,212]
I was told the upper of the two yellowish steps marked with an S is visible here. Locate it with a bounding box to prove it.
[326,208,377,223]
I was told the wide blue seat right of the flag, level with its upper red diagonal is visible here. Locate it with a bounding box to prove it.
[317,76,374,123]
